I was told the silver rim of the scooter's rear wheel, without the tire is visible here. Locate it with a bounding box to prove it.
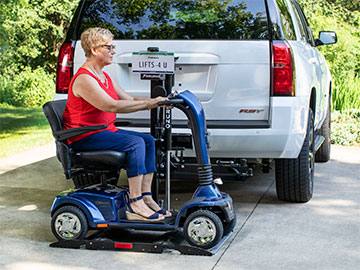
[55,213,81,240]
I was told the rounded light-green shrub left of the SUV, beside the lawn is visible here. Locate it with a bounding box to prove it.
[0,67,55,107]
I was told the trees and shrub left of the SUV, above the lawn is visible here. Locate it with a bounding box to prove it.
[0,0,78,107]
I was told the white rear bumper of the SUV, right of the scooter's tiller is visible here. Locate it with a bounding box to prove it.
[208,97,309,158]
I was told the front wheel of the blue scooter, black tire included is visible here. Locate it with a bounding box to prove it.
[183,210,224,249]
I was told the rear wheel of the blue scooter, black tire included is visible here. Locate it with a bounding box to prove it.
[51,205,88,241]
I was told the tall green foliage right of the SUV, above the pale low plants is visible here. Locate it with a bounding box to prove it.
[300,0,360,111]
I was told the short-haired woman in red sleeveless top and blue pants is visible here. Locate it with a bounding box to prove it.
[64,28,171,221]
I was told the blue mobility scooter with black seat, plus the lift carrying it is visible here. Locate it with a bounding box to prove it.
[43,51,236,255]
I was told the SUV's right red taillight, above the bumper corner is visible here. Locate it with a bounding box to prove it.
[272,41,295,96]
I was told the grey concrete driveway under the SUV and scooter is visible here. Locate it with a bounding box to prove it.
[0,144,360,270]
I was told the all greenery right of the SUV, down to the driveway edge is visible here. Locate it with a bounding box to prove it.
[300,0,360,145]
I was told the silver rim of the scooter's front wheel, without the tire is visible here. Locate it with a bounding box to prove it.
[187,217,216,245]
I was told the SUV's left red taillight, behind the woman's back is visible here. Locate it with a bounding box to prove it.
[56,41,74,94]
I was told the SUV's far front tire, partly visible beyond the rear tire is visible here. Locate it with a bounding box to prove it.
[315,102,331,162]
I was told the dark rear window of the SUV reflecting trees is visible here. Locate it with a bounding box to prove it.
[78,0,269,40]
